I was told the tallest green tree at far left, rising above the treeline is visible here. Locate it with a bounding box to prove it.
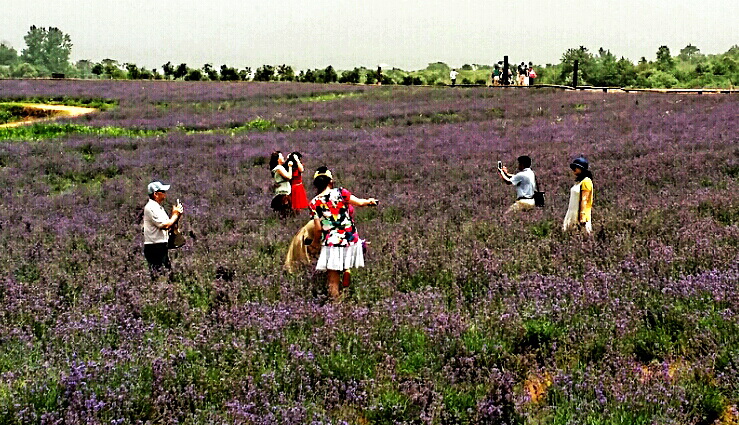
[21,25,72,72]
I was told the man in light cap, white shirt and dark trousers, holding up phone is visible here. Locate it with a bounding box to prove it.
[143,181,184,279]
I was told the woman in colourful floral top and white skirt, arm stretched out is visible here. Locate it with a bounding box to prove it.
[306,167,377,301]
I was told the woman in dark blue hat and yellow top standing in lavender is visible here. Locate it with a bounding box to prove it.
[562,157,593,234]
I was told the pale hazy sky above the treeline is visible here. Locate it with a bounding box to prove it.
[0,0,739,70]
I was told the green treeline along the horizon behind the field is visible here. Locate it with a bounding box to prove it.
[0,26,739,88]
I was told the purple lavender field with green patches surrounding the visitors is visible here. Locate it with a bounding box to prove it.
[0,80,739,425]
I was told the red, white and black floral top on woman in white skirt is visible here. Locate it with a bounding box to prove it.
[310,188,359,246]
